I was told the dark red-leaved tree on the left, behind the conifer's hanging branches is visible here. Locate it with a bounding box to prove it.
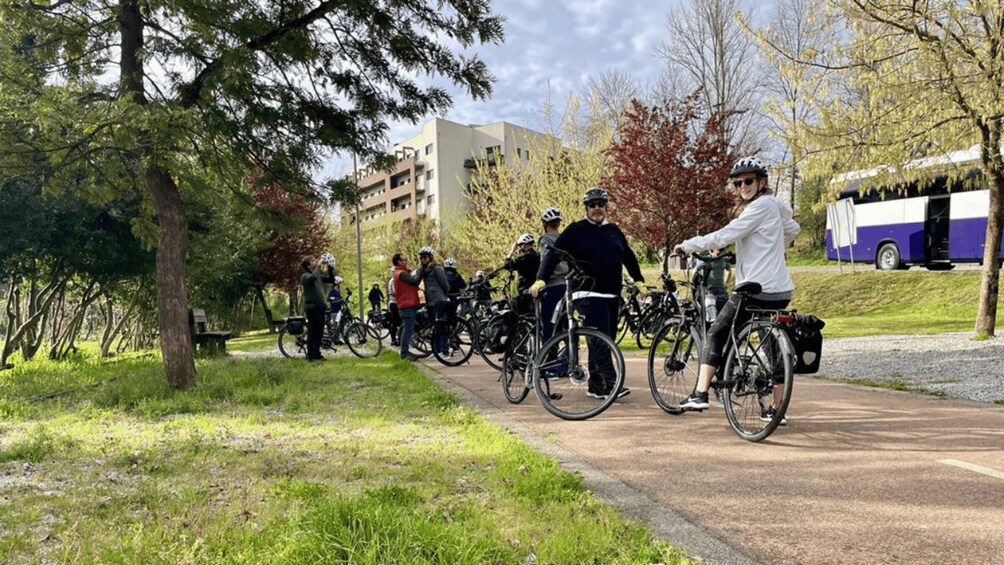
[253,178,328,320]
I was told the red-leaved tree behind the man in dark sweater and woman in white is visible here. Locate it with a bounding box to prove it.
[600,93,734,272]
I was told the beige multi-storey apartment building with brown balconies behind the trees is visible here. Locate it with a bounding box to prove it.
[342,118,558,227]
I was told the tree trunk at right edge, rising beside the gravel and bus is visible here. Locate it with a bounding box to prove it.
[973,167,1004,336]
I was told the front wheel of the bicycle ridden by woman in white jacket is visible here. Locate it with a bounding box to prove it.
[649,316,701,414]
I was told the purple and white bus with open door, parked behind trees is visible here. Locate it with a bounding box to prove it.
[826,170,1004,270]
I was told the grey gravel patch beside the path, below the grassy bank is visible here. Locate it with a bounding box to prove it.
[819,333,1004,402]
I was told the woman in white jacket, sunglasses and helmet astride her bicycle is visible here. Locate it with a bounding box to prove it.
[674,157,800,425]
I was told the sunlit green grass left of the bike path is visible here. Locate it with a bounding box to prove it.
[0,354,686,564]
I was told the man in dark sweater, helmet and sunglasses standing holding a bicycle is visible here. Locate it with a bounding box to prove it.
[530,187,645,397]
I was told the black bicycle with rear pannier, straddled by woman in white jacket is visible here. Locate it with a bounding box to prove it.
[649,254,796,442]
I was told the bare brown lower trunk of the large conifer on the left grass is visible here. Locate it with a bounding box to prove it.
[145,164,196,388]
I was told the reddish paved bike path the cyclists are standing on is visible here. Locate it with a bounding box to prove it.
[424,357,1004,563]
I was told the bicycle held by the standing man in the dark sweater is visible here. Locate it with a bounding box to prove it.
[507,248,624,420]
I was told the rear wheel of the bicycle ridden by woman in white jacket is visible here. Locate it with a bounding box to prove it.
[722,321,794,442]
